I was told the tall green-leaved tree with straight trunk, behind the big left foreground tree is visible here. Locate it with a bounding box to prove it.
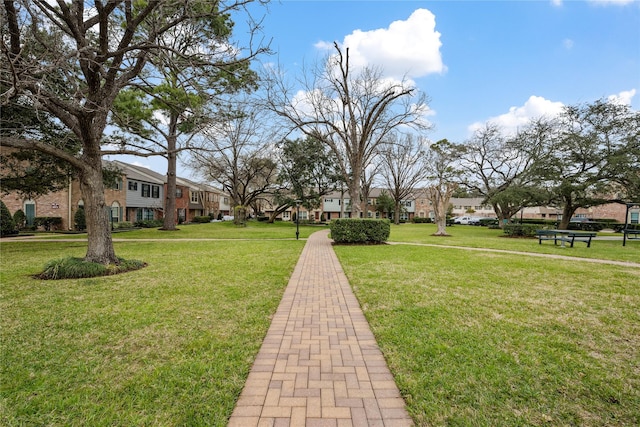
[113,8,264,230]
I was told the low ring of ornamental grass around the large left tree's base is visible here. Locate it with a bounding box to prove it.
[36,257,146,280]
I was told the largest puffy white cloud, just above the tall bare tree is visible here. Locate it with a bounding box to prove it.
[316,9,447,79]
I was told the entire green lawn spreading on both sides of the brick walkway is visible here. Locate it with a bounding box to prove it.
[0,222,640,426]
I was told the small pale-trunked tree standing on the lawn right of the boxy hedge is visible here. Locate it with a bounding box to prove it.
[425,139,460,236]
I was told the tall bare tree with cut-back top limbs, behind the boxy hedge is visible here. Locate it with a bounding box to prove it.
[265,43,429,217]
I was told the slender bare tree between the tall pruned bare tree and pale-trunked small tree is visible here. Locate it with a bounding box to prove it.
[380,134,429,224]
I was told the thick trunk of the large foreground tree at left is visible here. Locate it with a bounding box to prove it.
[79,154,118,264]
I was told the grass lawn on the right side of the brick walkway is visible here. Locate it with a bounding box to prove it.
[335,225,640,426]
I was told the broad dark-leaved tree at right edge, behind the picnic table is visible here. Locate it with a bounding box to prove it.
[531,100,640,228]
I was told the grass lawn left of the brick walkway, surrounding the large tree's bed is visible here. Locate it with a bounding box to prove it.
[0,237,304,426]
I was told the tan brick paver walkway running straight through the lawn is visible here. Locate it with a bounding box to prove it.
[229,230,412,427]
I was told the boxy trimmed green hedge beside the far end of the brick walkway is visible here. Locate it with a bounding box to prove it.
[329,218,391,243]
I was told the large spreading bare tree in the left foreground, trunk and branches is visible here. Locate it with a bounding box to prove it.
[0,0,266,264]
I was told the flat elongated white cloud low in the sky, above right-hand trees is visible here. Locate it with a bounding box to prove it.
[468,95,564,133]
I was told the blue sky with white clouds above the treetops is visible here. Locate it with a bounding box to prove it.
[111,0,640,177]
